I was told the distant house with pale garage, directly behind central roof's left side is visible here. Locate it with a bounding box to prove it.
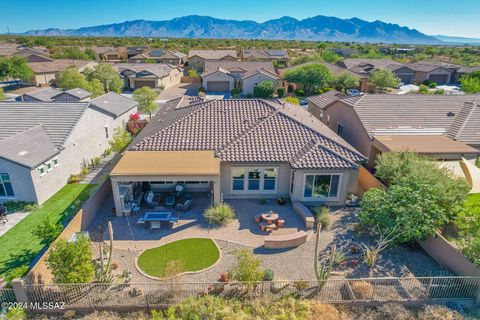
[113,63,183,90]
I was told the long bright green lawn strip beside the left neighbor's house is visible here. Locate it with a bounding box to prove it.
[0,184,97,277]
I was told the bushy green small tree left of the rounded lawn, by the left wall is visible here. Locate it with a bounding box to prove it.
[46,235,95,283]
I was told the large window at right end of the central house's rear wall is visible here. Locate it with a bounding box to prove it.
[303,174,340,199]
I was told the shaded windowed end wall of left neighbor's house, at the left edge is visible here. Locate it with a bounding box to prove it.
[0,158,37,202]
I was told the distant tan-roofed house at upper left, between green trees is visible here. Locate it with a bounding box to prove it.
[27,59,98,86]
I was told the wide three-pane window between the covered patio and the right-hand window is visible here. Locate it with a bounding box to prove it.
[232,168,278,193]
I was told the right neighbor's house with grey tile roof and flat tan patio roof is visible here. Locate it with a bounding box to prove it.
[308,90,480,166]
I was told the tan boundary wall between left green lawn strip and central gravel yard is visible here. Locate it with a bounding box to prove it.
[24,179,112,284]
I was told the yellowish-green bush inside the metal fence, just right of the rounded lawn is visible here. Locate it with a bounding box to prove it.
[228,249,264,284]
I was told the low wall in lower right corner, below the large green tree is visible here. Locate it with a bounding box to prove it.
[418,233,480,277]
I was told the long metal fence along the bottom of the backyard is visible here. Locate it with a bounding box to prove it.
[8,277,480,308]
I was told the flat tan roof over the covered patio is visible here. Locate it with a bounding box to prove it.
[111,151,220,176]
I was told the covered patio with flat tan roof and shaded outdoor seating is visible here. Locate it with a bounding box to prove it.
[110,151,220,216]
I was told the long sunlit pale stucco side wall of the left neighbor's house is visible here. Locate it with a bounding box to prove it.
[32,108,136,203]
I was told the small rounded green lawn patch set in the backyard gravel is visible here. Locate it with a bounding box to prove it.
[138,238,220,278]
